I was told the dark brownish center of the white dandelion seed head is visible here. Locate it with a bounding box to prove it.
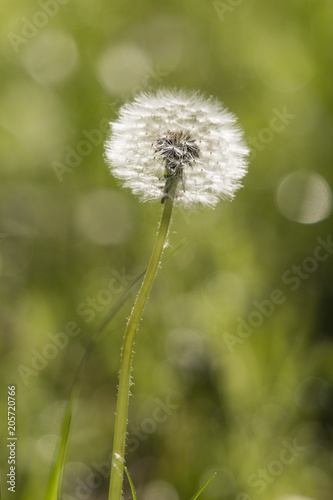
[155,132,200,168]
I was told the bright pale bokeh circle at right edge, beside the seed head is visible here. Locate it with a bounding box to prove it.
[276,170,332,224]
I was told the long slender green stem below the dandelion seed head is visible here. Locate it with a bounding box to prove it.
[109,196,173,500]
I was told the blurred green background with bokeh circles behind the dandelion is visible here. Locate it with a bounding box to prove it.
[0,0,333,500]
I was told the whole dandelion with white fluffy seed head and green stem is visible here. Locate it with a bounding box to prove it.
[105,90,248,500]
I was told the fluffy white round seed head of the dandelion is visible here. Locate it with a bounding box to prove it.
[105,89,249,206]
